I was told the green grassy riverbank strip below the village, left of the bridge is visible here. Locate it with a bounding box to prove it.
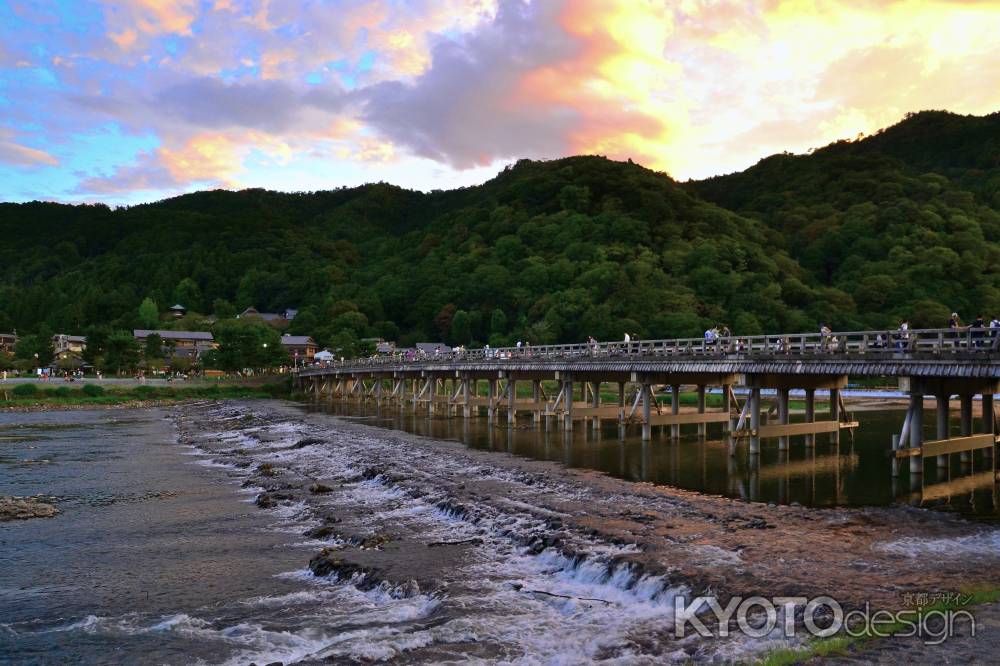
[0,382,290,409]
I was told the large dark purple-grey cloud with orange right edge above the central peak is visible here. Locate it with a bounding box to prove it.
[362,3,579,168]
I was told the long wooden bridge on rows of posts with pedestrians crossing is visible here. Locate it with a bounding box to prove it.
[295,328,1000,475]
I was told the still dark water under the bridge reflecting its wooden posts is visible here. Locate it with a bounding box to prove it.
[312,403,1000,520]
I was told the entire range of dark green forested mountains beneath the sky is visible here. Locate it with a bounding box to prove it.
[0,112,1000,346]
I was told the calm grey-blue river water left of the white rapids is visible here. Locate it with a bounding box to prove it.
[0,410,302,664]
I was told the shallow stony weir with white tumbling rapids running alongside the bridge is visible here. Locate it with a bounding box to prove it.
[176,396,1000,662]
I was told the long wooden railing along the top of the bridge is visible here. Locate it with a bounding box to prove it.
[298,328,1000,374]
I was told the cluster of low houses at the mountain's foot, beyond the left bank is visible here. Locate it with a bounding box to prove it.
[0,304,451,377]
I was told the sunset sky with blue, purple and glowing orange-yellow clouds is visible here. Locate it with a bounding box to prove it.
[0,0,1000,205]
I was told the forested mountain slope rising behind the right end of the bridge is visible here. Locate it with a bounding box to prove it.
[686,111,1000,326]
